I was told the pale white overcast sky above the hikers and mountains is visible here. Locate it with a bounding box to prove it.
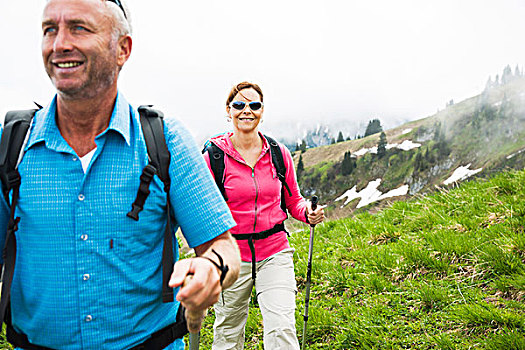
[0,0,525,139]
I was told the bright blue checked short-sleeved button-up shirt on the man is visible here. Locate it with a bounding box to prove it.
[0,93,235,350]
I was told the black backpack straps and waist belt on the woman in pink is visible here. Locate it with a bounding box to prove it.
[202,135,292,281]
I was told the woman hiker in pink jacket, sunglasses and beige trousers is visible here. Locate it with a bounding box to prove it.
[205,82,324,350]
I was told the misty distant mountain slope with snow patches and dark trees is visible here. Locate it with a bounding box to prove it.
[294,77,525,217]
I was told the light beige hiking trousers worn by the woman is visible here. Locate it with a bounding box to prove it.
[212,248,299,350]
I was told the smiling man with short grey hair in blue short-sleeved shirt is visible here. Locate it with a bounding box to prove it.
[0,0,240,349]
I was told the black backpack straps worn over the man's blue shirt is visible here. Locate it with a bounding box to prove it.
[0,106,182,346]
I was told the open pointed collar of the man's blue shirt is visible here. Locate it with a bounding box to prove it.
[27,92,135,152]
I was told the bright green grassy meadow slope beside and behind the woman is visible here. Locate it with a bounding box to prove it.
[0,171,525,350]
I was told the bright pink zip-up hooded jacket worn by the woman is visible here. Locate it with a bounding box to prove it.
[204,132,312,261]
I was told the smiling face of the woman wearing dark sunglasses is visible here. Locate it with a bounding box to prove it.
[226,88,264,133]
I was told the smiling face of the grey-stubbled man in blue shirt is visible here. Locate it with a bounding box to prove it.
[42,0,120,98]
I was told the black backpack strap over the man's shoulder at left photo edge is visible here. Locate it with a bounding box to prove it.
[0,109,37,203]
